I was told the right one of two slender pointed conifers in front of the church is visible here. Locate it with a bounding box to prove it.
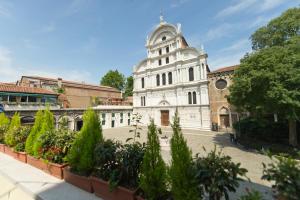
[169,111,202,200]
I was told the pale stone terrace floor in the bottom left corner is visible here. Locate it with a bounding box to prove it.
[0,153,101,200]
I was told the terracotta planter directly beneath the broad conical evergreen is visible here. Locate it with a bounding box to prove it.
[64,167,93,193]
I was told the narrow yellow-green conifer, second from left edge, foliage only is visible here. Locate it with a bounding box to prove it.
[4,112,21,147]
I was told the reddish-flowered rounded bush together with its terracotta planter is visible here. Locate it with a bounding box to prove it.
[38,128,74,179]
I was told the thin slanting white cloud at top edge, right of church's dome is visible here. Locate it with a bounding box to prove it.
[216,0,257,18]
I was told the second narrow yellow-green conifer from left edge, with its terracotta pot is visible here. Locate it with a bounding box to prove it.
[4,112,21,158]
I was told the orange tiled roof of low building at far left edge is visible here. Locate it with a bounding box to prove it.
[0,83,57,95]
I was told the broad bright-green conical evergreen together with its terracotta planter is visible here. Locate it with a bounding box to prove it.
[64,109,103,192]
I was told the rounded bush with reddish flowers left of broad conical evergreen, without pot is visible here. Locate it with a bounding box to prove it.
[38,129,75,164]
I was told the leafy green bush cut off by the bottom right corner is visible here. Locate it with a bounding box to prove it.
[262,155,300,200]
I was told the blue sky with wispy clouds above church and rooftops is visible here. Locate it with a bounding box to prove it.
[0,0,300,84]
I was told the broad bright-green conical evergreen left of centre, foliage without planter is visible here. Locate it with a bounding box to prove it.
[67,109,103,175]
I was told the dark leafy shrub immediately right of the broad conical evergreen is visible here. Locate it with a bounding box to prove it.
[94,140,122,189]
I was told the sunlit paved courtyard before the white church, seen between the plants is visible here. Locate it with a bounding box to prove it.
[103,127,272,199]
